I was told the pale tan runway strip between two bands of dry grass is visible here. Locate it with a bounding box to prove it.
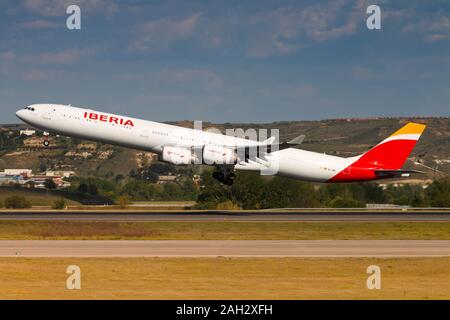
[0,240,450,258]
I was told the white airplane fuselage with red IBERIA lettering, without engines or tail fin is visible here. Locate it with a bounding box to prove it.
[16,104,426,182]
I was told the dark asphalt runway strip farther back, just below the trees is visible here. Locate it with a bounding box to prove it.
[0,210,450,222]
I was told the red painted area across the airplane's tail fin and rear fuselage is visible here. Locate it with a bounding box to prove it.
[328,140,417,182]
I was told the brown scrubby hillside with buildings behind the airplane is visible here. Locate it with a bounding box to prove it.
[0,118,450,178]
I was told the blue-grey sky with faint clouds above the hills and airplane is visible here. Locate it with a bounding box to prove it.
[0,0,450,123]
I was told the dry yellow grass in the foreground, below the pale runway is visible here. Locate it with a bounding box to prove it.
[0,258,450,299]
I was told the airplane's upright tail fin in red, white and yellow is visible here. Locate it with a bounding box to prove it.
[352,122,426,170]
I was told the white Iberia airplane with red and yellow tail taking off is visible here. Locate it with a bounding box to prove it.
[16,104,426,185]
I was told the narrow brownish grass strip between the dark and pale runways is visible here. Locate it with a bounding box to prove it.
[0,221,450,240]
